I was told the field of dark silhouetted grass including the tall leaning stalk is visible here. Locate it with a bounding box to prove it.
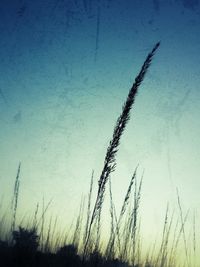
[0,43,198,267]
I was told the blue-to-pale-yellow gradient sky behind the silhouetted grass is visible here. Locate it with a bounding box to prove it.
[0,0,200,262]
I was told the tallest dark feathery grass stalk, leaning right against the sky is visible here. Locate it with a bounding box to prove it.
[83,42,160,258]
